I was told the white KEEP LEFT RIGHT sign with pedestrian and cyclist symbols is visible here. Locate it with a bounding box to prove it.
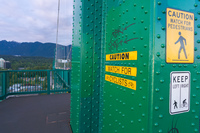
[169,71,190,115]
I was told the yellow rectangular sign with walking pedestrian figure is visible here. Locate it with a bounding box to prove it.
[166,8,194,63]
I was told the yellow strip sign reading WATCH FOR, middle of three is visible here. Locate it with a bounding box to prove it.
[106,65,137,76]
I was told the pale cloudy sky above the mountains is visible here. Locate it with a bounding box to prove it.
[0,0,73,45]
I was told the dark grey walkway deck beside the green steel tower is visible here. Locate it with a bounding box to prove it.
[0,94,71,133]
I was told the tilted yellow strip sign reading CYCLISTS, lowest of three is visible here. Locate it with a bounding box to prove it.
[105,74,136,90]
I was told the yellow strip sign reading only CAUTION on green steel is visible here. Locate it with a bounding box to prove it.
[106,51,137,61]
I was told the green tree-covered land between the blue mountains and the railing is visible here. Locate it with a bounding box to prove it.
[0,55,53,70]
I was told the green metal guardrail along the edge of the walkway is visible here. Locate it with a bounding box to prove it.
[0,69,71,100]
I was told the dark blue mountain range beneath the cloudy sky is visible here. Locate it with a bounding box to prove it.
[0,40,71,58]
